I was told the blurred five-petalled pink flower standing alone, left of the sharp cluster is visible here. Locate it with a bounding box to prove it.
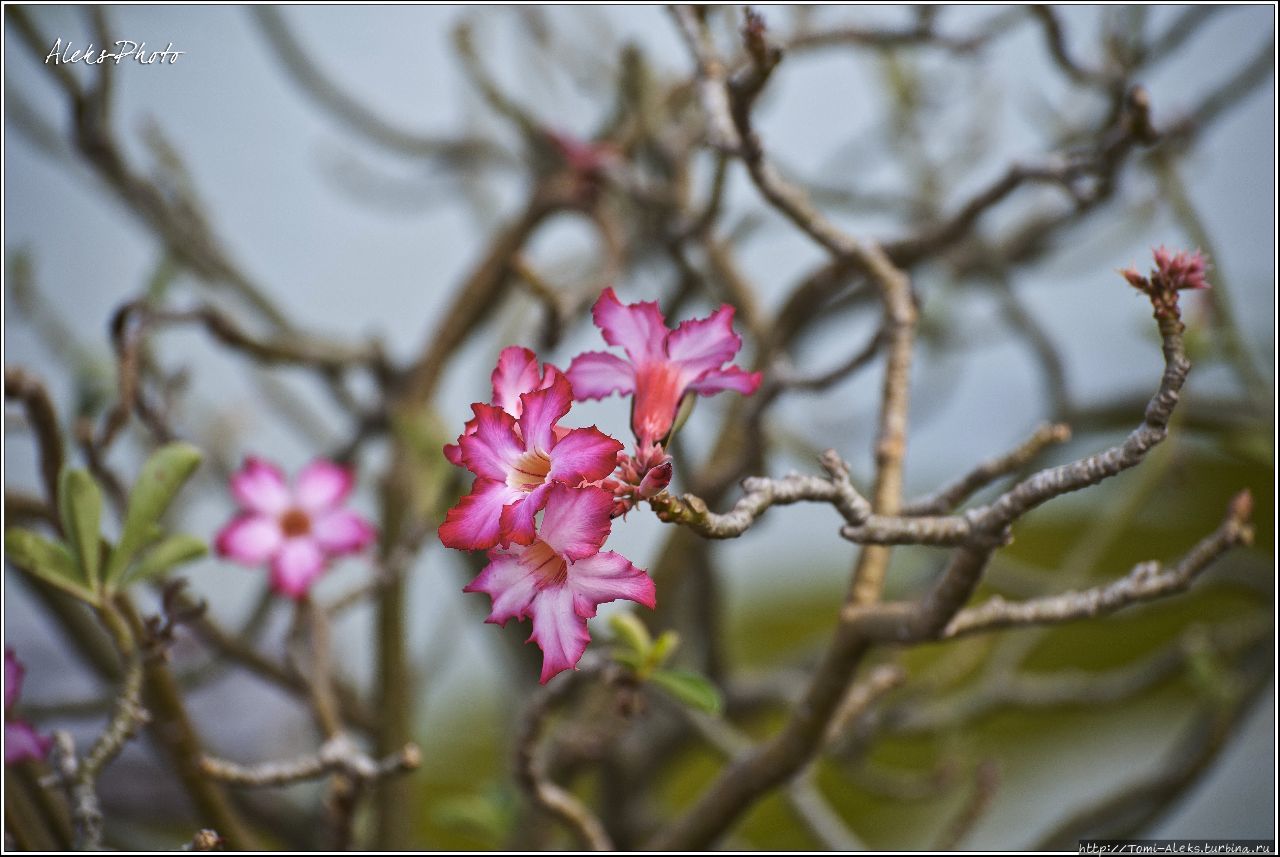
[216,455,378,599]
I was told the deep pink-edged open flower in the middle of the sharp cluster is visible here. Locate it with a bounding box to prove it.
[440,371,622,550]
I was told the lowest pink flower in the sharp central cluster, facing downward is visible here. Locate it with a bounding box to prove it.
[463,485,655,684]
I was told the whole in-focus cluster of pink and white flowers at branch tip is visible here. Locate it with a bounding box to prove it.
[439,288,760,683]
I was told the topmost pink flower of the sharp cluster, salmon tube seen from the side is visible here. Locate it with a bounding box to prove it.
[568,288,760,445]
